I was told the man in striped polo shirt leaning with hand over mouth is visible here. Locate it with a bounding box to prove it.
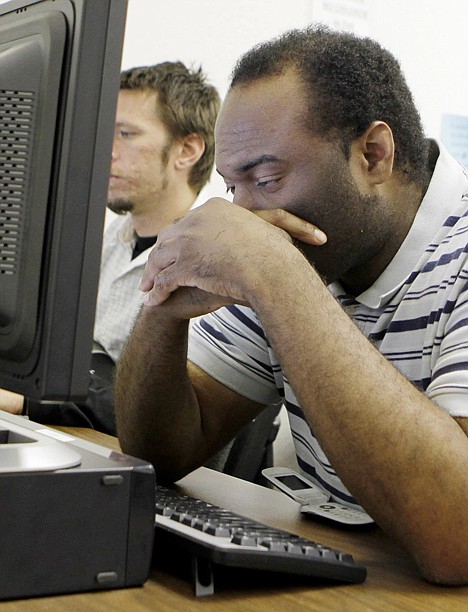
[115,28,468,584]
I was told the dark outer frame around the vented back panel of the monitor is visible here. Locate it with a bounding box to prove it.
[0,0,127,400]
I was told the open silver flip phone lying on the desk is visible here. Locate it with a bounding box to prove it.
[262,467,374,526]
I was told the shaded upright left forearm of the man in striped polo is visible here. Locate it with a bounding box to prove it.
[114,307,200,479]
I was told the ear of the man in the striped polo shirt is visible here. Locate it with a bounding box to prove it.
[351,121,395,186]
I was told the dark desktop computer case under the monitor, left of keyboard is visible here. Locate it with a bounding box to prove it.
[0,411,155,599]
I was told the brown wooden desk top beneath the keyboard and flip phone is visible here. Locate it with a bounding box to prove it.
[0,428,468,612]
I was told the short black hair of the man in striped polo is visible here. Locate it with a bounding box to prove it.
[230,26,429,186]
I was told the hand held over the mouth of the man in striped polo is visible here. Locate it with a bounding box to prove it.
[140,198,326,316]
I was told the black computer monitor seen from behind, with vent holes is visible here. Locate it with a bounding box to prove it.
[0,0,127,400]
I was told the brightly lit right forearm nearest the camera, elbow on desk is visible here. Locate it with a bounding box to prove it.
[253,253,468,582]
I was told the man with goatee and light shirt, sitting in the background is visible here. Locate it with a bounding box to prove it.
[0,62,220,434]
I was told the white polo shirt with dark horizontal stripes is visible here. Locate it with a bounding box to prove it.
[189,143,468,505]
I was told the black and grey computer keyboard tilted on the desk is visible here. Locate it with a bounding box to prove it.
[155,486,367,596]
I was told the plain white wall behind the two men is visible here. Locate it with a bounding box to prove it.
[122,0,468,206]
